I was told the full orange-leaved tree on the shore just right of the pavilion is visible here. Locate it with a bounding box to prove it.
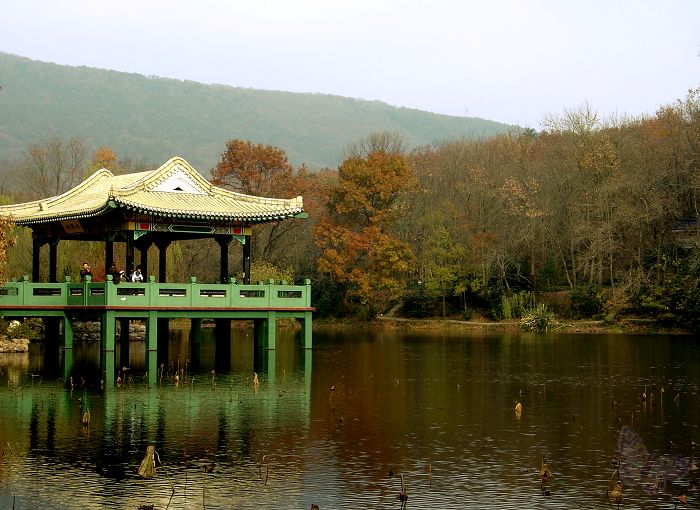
[314,151,415,318]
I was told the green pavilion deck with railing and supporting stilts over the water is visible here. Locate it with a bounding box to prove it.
[0,276,313,382]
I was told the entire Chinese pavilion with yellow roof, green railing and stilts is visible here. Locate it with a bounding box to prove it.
[0,157,313,382]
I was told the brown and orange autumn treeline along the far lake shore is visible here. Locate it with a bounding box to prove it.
[4,89,700,327]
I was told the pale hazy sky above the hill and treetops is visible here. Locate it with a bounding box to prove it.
[0,0,700,128]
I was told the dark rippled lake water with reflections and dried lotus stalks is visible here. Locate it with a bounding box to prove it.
[0,330,700,510]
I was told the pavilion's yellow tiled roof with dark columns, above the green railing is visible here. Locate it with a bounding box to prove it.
[0,157,306,283]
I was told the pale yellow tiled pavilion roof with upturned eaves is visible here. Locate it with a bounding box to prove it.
[0,157,303,225]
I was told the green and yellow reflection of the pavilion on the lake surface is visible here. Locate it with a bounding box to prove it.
[0,342,312,508]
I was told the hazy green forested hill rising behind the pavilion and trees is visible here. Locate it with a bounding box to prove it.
[0,53,509,171]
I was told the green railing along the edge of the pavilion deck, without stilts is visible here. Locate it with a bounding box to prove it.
[0,276,311,310]
